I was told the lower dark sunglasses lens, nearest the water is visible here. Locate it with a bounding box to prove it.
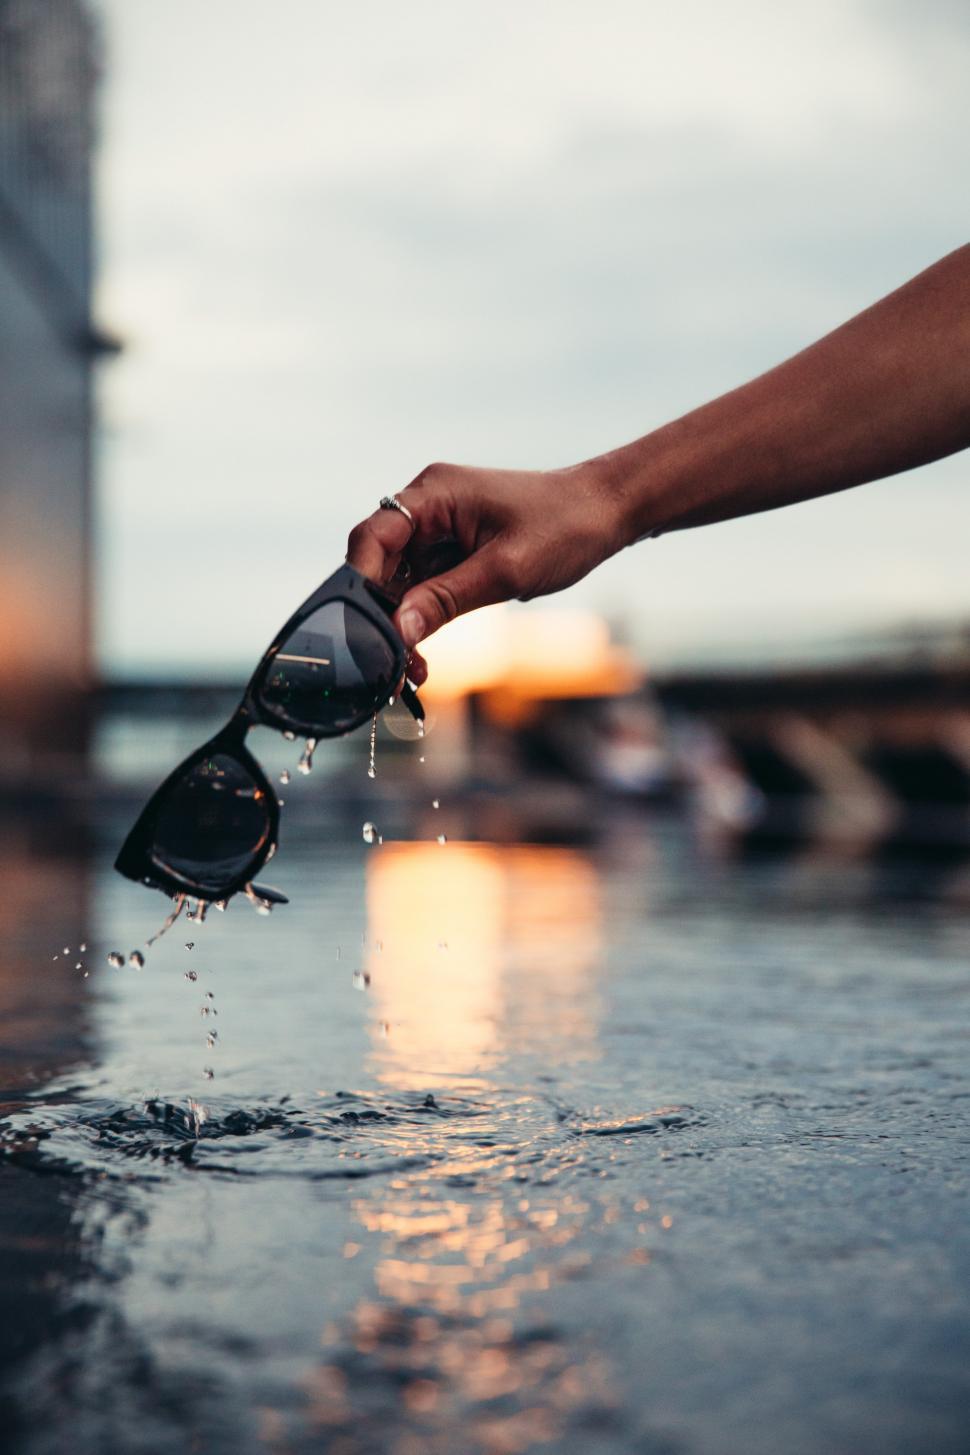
[151,752,270,890]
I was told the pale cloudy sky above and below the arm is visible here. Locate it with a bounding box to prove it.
[96,0,970,675]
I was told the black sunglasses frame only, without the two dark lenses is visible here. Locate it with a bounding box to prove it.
[115,563,425,902]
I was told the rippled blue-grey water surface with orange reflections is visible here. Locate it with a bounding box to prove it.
[0,805,970,1455]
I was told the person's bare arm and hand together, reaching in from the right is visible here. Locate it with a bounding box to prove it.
[348,246,970,666]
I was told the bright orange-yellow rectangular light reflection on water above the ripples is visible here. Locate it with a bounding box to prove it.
[366,842,601,1090]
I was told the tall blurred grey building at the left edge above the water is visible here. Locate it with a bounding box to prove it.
[0,0,109,780]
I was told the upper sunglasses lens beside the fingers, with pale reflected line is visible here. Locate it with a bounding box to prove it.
[257,601,396,738]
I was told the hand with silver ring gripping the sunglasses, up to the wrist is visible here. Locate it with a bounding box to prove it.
[348,464,627,682]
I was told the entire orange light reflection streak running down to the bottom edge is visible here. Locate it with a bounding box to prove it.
[298,844,615,1455]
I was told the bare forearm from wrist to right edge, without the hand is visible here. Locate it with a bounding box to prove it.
[596,246,970,543]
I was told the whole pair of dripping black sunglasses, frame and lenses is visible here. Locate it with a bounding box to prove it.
[115,566,425,912]
